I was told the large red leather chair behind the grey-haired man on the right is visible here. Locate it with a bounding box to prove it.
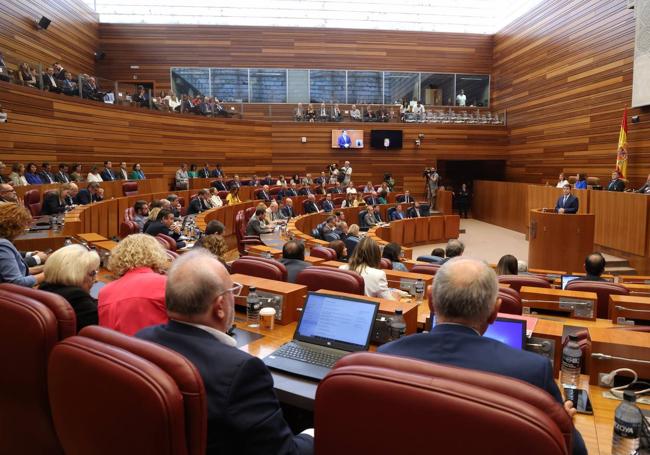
[314,352,573,455]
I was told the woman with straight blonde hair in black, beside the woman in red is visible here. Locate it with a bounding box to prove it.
[39,245,100,331]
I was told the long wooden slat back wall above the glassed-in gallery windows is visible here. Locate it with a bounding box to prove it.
[98,24,493,89]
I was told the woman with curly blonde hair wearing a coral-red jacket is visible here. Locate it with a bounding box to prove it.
[99,234,169,335]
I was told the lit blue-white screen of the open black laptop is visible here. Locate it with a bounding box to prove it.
[298,294,376,346]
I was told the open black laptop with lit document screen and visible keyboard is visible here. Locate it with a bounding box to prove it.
[263,292,379,380]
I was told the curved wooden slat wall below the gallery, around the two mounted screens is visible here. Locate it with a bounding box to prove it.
[0,82,508,193]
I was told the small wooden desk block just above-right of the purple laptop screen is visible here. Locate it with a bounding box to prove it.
[519,286,598,320]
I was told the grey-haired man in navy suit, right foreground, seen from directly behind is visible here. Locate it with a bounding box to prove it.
[378,259,587,454]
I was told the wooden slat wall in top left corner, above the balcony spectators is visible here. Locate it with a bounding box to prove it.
[0,0,99,74]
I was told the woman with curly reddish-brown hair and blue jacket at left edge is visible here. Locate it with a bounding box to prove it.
[0,202,44,287]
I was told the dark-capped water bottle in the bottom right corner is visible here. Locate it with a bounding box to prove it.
[612,390,643,455]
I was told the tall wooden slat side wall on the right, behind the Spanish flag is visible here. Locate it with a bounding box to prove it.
[492,0,650,186]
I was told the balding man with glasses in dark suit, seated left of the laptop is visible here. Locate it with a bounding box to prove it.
[136,250,313,455]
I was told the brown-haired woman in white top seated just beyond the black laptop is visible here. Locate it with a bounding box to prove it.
[339,237,396,300]
